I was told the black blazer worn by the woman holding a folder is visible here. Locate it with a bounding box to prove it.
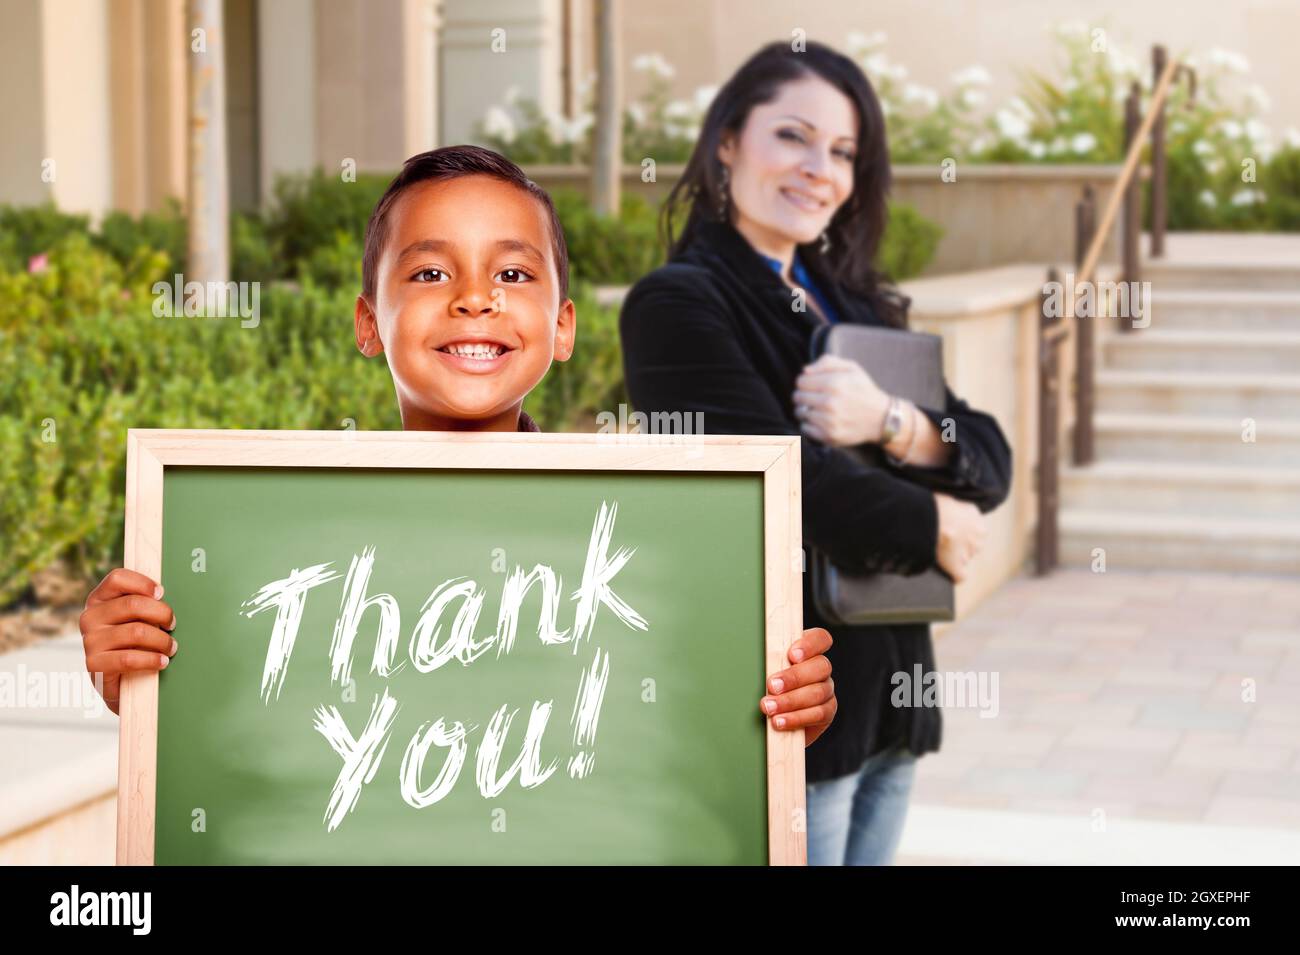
[620,222,1011,782]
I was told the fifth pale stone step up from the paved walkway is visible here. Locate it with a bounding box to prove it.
[1101,324,1300,374]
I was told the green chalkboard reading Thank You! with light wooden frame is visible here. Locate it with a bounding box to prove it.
[118,430,805,864]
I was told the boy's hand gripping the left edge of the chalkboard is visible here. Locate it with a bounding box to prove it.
[81,568,176,713]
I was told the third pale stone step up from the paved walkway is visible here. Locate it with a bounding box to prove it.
[1092,412,1300,468]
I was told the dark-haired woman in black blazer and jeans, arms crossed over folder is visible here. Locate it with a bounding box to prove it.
[620,43,1011,865]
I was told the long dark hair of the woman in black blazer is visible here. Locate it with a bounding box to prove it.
[660,42,910,327]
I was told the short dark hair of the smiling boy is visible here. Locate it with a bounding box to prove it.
[361,146,568,301]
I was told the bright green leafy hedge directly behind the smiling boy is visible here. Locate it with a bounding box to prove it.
[0,234,624,607]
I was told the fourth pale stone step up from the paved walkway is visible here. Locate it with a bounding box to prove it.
[1096,369,1300,420]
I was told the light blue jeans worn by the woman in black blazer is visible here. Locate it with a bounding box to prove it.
[807,747,917,865]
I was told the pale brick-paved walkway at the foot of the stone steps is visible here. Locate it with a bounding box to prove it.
[900,569,1300,863]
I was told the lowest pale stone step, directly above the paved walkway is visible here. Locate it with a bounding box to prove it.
[1058,508,1300,571]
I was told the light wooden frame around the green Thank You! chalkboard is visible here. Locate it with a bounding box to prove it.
[117,429,807,865]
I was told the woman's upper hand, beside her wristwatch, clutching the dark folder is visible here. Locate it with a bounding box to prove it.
[794,355,889,447]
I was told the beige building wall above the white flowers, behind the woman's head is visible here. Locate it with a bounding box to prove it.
[623,0,1300,140]
